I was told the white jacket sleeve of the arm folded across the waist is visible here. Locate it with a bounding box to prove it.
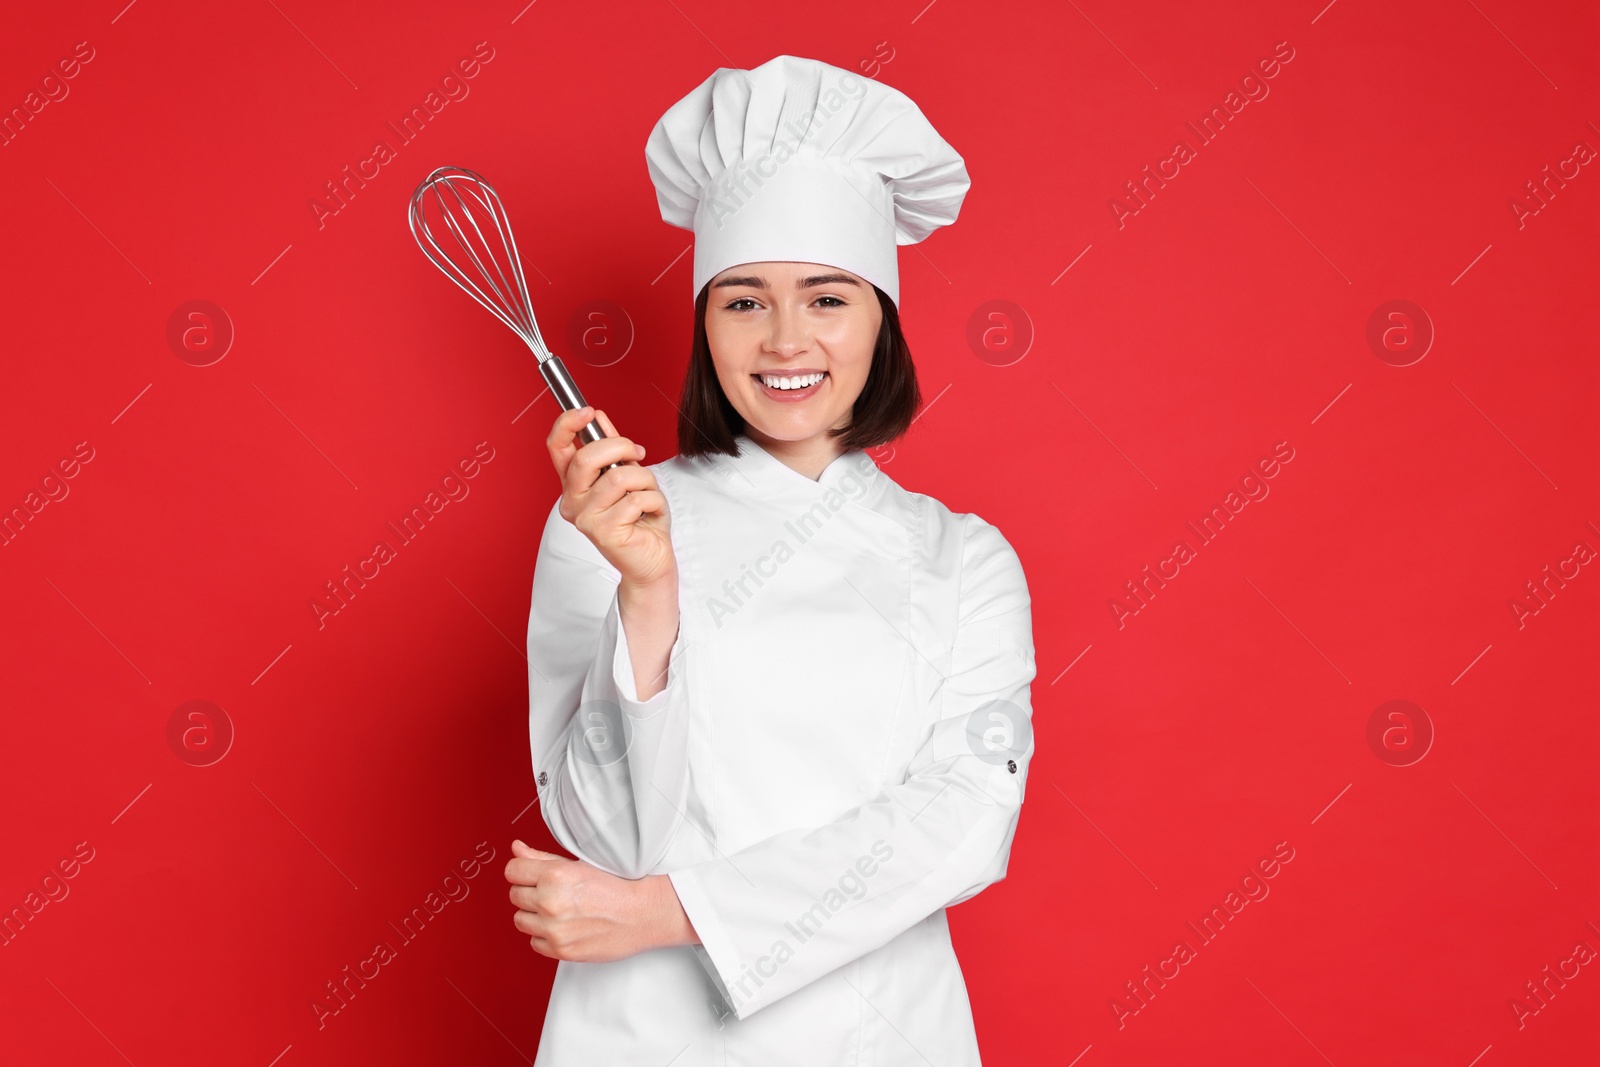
[669,515,1035,1019]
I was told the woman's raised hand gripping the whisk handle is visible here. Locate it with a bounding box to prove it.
[546,406,678,591]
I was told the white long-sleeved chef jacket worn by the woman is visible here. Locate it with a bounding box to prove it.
[528,435,1035,1067]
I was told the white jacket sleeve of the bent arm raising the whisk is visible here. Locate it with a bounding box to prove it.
[528,501,688,878]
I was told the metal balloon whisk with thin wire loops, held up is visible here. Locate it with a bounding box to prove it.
[408,166,624,470]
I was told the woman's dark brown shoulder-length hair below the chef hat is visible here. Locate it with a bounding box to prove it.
[678,282,922,456]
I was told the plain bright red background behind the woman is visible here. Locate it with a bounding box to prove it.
[0,0,1600,1067]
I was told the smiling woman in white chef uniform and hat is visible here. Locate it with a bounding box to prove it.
[506,56,1035,1067]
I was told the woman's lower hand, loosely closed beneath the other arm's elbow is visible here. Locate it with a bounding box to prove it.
[506,841,699,963]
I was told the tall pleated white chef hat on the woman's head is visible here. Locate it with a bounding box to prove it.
[645,56,971,306]
